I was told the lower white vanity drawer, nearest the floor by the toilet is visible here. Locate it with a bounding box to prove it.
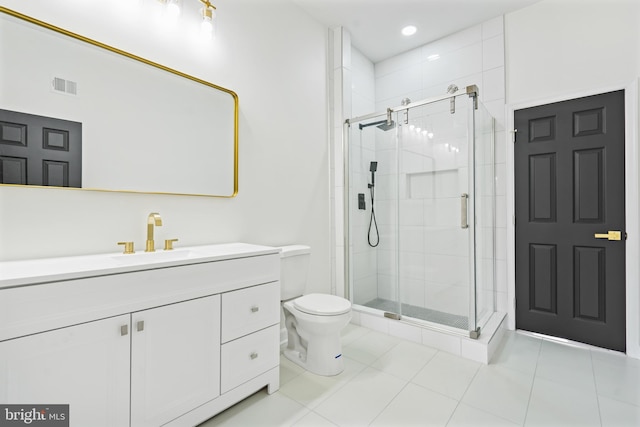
[220,325,280,393]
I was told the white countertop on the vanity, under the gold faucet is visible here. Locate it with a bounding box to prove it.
[0,243,280,289]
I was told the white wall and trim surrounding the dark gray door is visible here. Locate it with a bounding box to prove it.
[505,0,640,357]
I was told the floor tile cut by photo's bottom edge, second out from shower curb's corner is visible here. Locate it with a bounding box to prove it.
[370,384,458,427]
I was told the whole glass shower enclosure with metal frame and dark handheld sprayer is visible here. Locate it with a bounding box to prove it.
[344,86,496,338]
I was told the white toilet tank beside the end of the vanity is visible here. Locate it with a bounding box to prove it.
[280,245,311,301]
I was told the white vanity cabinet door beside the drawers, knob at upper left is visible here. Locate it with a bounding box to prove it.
[131,295,220,427]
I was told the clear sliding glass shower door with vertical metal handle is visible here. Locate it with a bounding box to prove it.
[396,96,475,330]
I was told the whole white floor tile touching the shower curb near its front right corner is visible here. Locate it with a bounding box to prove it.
[411,352,480,399]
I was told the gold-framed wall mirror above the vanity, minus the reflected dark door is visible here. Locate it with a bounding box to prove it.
[0,6,238,198]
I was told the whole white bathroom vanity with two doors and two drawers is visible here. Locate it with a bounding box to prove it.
[0,244,280,427]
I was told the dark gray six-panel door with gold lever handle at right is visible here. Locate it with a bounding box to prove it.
[514,91,626,351]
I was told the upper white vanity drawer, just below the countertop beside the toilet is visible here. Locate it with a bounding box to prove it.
[221,282,280,343]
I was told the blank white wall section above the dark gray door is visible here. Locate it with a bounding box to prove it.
[505,0,640,103]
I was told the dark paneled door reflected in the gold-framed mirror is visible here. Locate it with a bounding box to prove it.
[0,110,82,187]
